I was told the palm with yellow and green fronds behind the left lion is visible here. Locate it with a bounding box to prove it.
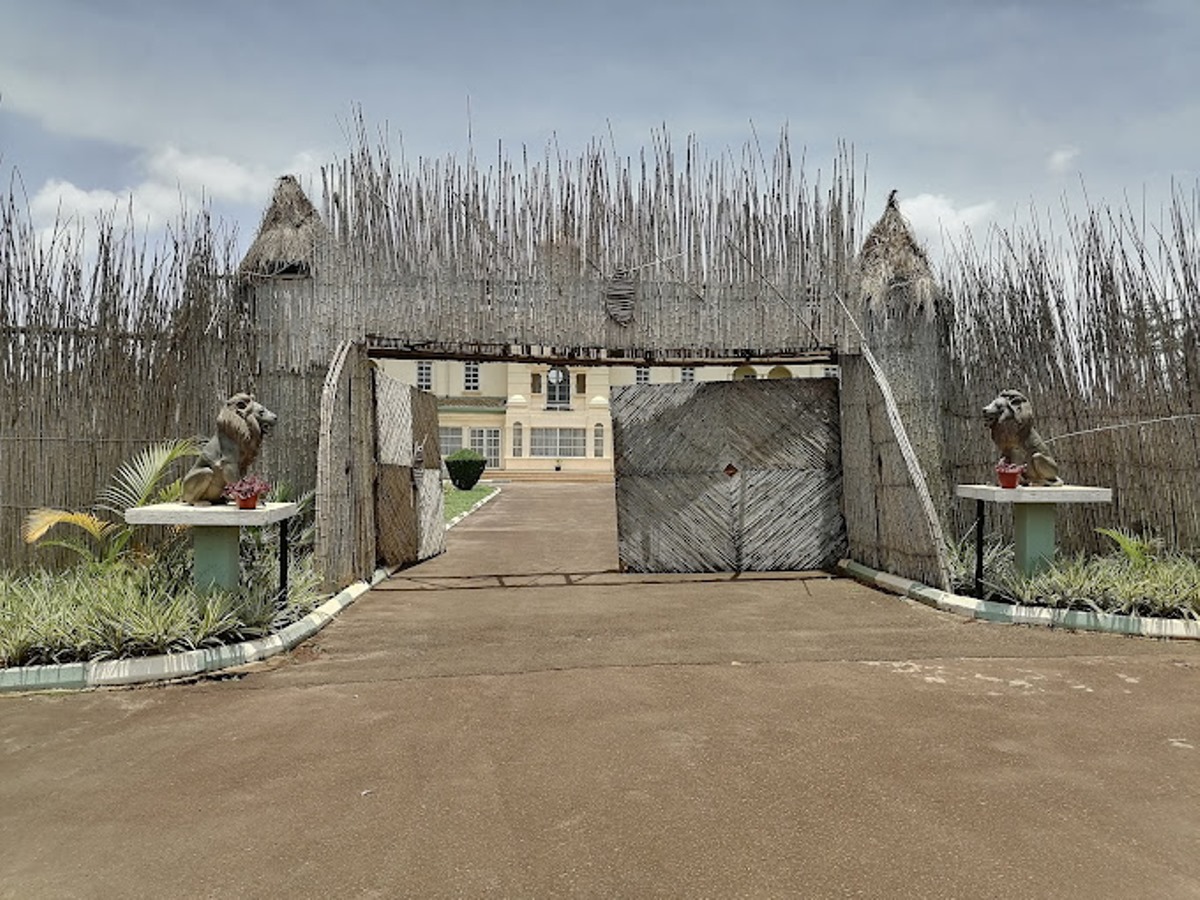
[20,438,198,564]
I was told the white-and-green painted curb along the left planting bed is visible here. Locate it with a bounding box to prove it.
[0,569,392,694]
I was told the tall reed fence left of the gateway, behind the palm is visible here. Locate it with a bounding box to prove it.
[0,193,324,568]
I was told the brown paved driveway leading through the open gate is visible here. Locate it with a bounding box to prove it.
[0,484,1200,898]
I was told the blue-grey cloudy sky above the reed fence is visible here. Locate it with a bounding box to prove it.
[0,0,1200,267]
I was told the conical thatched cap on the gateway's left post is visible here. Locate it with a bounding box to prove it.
[238,175,326,277]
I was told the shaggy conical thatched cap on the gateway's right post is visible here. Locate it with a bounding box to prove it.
[858,191,936,318]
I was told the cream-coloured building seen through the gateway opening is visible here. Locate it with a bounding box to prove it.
[379,360,838,473]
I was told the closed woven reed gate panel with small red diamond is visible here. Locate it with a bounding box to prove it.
[611,379,846,572]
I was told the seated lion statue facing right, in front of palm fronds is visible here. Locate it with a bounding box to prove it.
[182,394,276,505]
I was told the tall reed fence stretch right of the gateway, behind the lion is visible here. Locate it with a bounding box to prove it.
[941,191,1200,552]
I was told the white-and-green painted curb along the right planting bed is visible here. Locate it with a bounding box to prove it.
[836,559,1200,641]
